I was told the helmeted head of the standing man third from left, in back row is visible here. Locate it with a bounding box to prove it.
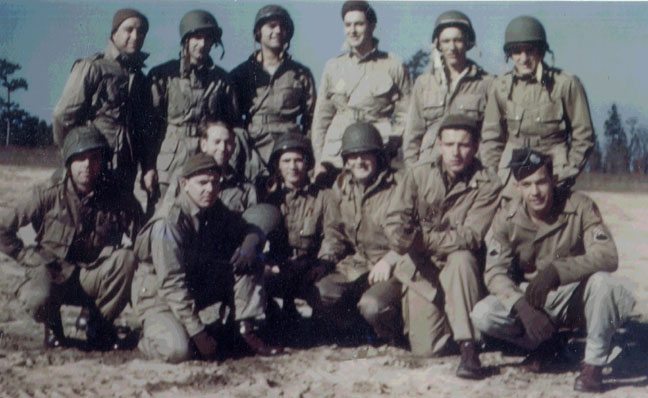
[253,4,295,51]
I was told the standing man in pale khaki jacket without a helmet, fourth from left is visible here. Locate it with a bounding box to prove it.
[312,1,410,175]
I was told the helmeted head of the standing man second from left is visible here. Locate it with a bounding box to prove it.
[180,10,223,65]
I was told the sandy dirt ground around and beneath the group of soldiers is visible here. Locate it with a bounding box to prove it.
[0,151,648,398]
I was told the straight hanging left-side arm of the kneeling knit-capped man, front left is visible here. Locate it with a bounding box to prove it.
[151,220,205,337]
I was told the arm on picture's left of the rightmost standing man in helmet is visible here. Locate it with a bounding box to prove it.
[479,81,507,170]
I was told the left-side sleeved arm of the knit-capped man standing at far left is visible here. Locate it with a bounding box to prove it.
[52,60,97,148]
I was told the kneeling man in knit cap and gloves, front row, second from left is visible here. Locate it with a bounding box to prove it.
[132,153,282,362]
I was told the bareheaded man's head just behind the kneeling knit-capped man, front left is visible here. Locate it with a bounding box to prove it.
[198,119,236,167]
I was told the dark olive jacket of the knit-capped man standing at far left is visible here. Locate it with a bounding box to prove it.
[53,42,156,184]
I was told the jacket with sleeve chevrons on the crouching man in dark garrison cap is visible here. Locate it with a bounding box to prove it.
[484,192,618,308]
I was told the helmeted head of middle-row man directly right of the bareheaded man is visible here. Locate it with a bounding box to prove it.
[268,133,314,189]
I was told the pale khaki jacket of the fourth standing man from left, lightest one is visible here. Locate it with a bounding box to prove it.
[312,44,410,167]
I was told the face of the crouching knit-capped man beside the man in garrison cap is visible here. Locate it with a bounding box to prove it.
[440,128,477,177]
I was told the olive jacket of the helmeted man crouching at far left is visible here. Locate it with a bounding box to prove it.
[0,173,143,283]
